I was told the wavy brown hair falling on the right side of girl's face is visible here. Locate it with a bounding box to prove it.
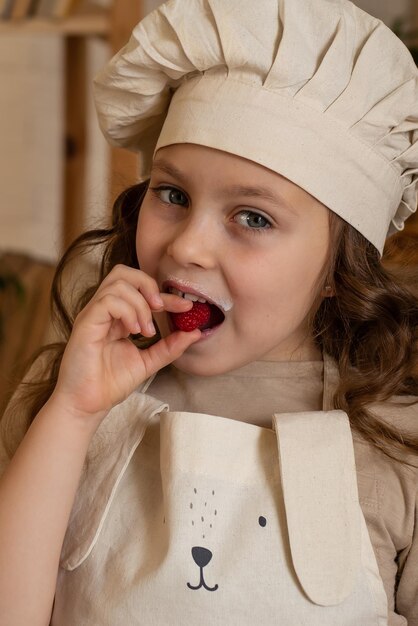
[313,214,418,460]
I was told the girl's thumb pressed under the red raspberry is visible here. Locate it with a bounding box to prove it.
[141,329,202,378]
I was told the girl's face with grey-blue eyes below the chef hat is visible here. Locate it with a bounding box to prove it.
[136,144,329,376]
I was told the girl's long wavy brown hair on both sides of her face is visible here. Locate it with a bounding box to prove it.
[3,181,418,458]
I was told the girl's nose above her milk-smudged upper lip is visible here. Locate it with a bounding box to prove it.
[167,214,219,269]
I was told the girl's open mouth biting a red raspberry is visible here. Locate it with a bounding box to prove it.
[167,287,225,332]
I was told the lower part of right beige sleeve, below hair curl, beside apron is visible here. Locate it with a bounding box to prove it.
[355,420,418,626]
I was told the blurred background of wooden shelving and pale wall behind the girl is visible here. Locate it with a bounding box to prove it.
[0,0,418,409]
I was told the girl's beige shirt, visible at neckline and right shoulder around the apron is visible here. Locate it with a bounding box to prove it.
[0,359,418,626]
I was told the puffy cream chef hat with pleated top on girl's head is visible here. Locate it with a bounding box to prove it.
[95,0,418,252]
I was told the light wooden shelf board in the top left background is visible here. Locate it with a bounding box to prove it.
[0,12,111,37]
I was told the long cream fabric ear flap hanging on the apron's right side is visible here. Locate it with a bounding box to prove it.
[273,411,361,606]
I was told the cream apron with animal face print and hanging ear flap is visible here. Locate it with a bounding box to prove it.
[51,372,388,626]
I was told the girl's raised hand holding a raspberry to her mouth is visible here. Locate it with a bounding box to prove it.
[53,265,201,421]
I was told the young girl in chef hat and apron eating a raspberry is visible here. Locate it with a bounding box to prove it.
[0,0,418,626]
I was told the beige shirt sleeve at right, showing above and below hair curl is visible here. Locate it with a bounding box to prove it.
[358,396,418,626]
